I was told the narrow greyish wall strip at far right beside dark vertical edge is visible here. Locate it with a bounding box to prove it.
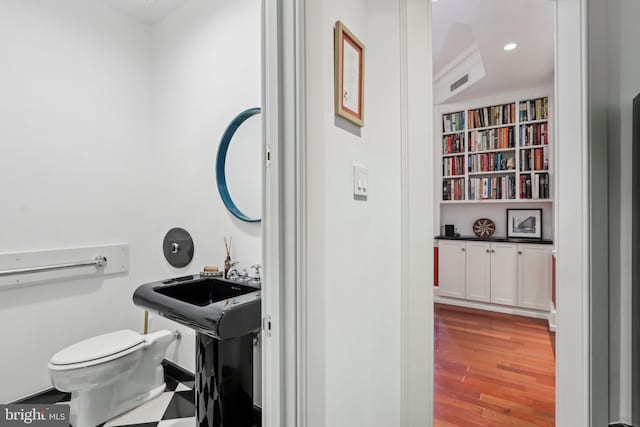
[607,0,640,425]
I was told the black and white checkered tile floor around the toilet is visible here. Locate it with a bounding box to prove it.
[20,365,260,427]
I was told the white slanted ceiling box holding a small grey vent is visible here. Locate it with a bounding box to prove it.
[433,44,486,104]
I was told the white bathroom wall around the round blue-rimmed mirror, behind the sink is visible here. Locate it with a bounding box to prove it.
[149,0,261,378]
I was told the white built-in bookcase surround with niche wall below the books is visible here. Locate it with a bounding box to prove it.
[433,86,555,239]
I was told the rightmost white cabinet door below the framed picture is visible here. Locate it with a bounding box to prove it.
[518,245,551,310]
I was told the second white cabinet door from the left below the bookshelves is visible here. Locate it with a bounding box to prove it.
[466,241,491,302]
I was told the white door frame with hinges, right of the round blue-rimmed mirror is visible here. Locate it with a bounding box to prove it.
[262,0,306,427]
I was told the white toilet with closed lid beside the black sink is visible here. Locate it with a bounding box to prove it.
[49,330,177,427]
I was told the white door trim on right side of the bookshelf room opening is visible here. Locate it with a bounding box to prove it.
[554,0,591,426]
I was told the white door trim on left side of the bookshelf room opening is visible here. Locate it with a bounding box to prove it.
[399,0,435,427]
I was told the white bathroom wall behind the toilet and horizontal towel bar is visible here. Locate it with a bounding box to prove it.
[0,0,151,402]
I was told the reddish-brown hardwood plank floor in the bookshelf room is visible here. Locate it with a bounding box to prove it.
[434,304,555,427]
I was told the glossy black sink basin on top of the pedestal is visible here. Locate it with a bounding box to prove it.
[133,275,260,340]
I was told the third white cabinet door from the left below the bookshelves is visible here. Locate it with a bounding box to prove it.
[491,243,518,305]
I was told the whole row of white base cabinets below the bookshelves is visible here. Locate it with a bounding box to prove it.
[438,240,551,311]
